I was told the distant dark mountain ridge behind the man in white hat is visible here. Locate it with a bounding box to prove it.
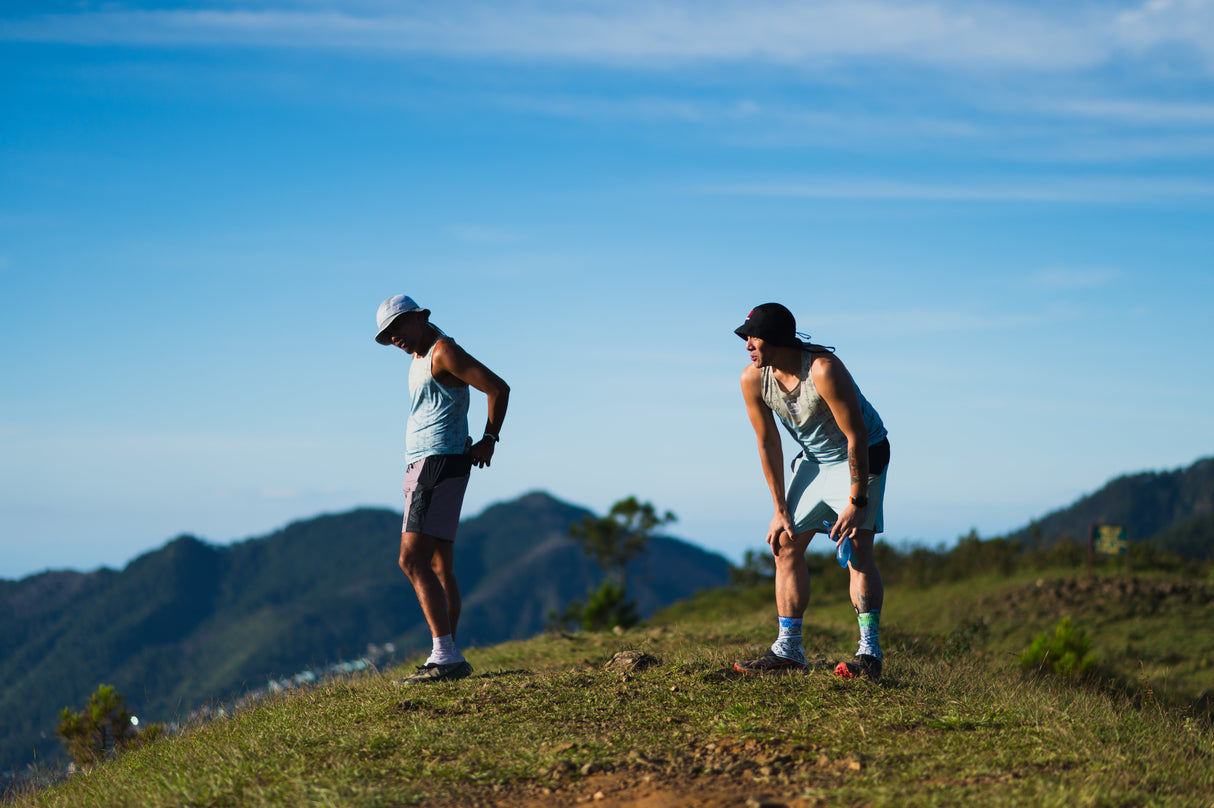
[0,493,730,770]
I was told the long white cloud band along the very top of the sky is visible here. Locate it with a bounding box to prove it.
[0,0,1214,70]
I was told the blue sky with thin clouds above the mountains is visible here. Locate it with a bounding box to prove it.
[0,0,1214,577]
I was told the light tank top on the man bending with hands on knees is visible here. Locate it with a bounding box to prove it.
[760,351,887,463]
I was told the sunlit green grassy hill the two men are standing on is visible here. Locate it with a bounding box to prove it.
[16,558,1214,808]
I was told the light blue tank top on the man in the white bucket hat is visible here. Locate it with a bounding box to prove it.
[404,328,469,463]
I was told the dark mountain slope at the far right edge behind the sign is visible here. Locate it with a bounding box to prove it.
[1008,457,1214,558]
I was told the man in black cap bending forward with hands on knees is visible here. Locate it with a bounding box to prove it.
[733,303,890,679]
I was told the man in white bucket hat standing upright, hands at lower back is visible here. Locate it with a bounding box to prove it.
[375,295,510,684]
